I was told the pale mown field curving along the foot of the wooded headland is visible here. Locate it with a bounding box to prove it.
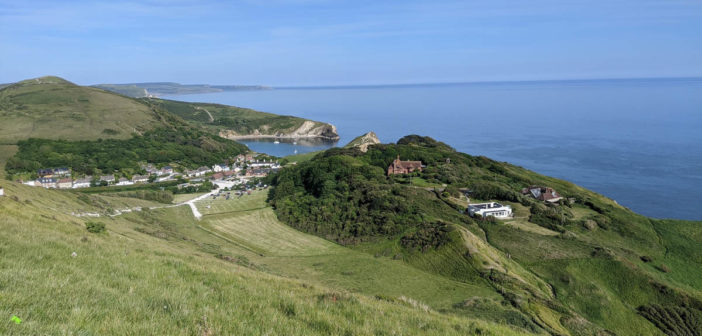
[197,191,498,309]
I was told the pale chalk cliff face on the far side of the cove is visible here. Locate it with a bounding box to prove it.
[219,120,339,141]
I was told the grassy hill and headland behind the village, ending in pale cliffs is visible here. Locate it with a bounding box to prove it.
[0,77,338,144]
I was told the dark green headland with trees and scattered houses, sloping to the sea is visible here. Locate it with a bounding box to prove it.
[270,136,702,335]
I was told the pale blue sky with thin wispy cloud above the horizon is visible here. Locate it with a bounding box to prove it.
[0,0,702,86]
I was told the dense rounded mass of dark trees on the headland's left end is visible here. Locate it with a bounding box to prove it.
[269,155,422,244]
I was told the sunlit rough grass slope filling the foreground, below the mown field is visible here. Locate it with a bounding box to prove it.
[0,183,524,335]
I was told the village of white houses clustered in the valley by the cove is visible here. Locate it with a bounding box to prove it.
[20,154,281,189]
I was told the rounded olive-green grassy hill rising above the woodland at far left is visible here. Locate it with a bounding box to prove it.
[0,77,163,144]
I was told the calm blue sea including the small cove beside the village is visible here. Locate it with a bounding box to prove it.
[167,78,702,220]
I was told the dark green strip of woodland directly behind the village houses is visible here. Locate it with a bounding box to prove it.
[6,127,248,175]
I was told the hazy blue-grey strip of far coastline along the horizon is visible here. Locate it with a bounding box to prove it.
[94,82,271,98]
